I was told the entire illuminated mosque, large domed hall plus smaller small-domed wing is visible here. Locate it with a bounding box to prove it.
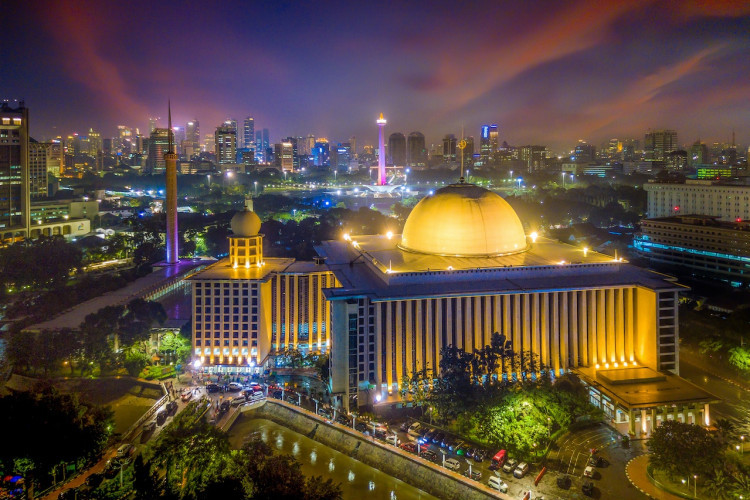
[191,182,715,434]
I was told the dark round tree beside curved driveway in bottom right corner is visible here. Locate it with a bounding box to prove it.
[647,420,723,477]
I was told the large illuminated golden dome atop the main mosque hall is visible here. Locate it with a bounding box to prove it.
[399,184,527,257]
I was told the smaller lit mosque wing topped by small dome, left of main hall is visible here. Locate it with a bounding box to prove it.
[190,203,336,373]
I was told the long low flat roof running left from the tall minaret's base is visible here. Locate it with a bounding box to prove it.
[24,260,206,331]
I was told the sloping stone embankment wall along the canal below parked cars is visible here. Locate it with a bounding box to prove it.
[241,400,510,500]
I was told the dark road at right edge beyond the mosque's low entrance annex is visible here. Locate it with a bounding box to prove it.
[680,357,750,435]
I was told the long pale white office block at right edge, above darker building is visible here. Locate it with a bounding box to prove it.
[643,179,750,221]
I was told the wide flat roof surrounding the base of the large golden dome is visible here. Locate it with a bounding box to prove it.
[316,236,687,301]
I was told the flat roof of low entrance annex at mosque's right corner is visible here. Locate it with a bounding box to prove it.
[574,367,720,409]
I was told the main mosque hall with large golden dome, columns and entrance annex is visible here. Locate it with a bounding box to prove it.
[317,184,712,432]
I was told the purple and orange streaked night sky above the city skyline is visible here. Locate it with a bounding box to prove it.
[5,0,750,150]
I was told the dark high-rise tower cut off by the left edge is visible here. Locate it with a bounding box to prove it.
[0,101,31,238]
